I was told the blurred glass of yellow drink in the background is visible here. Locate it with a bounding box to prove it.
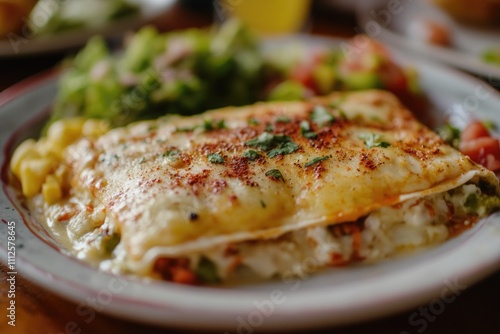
[215,0,311,35]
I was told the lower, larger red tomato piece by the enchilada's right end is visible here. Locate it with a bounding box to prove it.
[459,137,500,171]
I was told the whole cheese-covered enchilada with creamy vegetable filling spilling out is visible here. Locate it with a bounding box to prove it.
[12,91,500,283]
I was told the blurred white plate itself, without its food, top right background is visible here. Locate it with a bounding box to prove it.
[356,0,500,79]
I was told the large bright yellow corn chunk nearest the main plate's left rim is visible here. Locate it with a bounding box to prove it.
[20,158,53,197]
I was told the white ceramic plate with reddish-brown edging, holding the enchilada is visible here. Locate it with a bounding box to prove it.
[0,37,500,333]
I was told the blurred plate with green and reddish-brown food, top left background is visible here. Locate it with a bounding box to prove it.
[0,0,175,57]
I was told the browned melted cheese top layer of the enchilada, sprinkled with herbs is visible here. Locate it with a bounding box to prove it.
[41,91,497,271]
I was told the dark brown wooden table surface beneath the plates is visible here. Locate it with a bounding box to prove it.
[0,4,500,334]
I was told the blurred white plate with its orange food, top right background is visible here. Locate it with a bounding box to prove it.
[356,0,500,79]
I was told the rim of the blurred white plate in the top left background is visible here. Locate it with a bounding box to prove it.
[0,0,175,57]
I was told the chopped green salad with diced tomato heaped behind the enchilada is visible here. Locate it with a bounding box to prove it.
[49,20,420,126]
